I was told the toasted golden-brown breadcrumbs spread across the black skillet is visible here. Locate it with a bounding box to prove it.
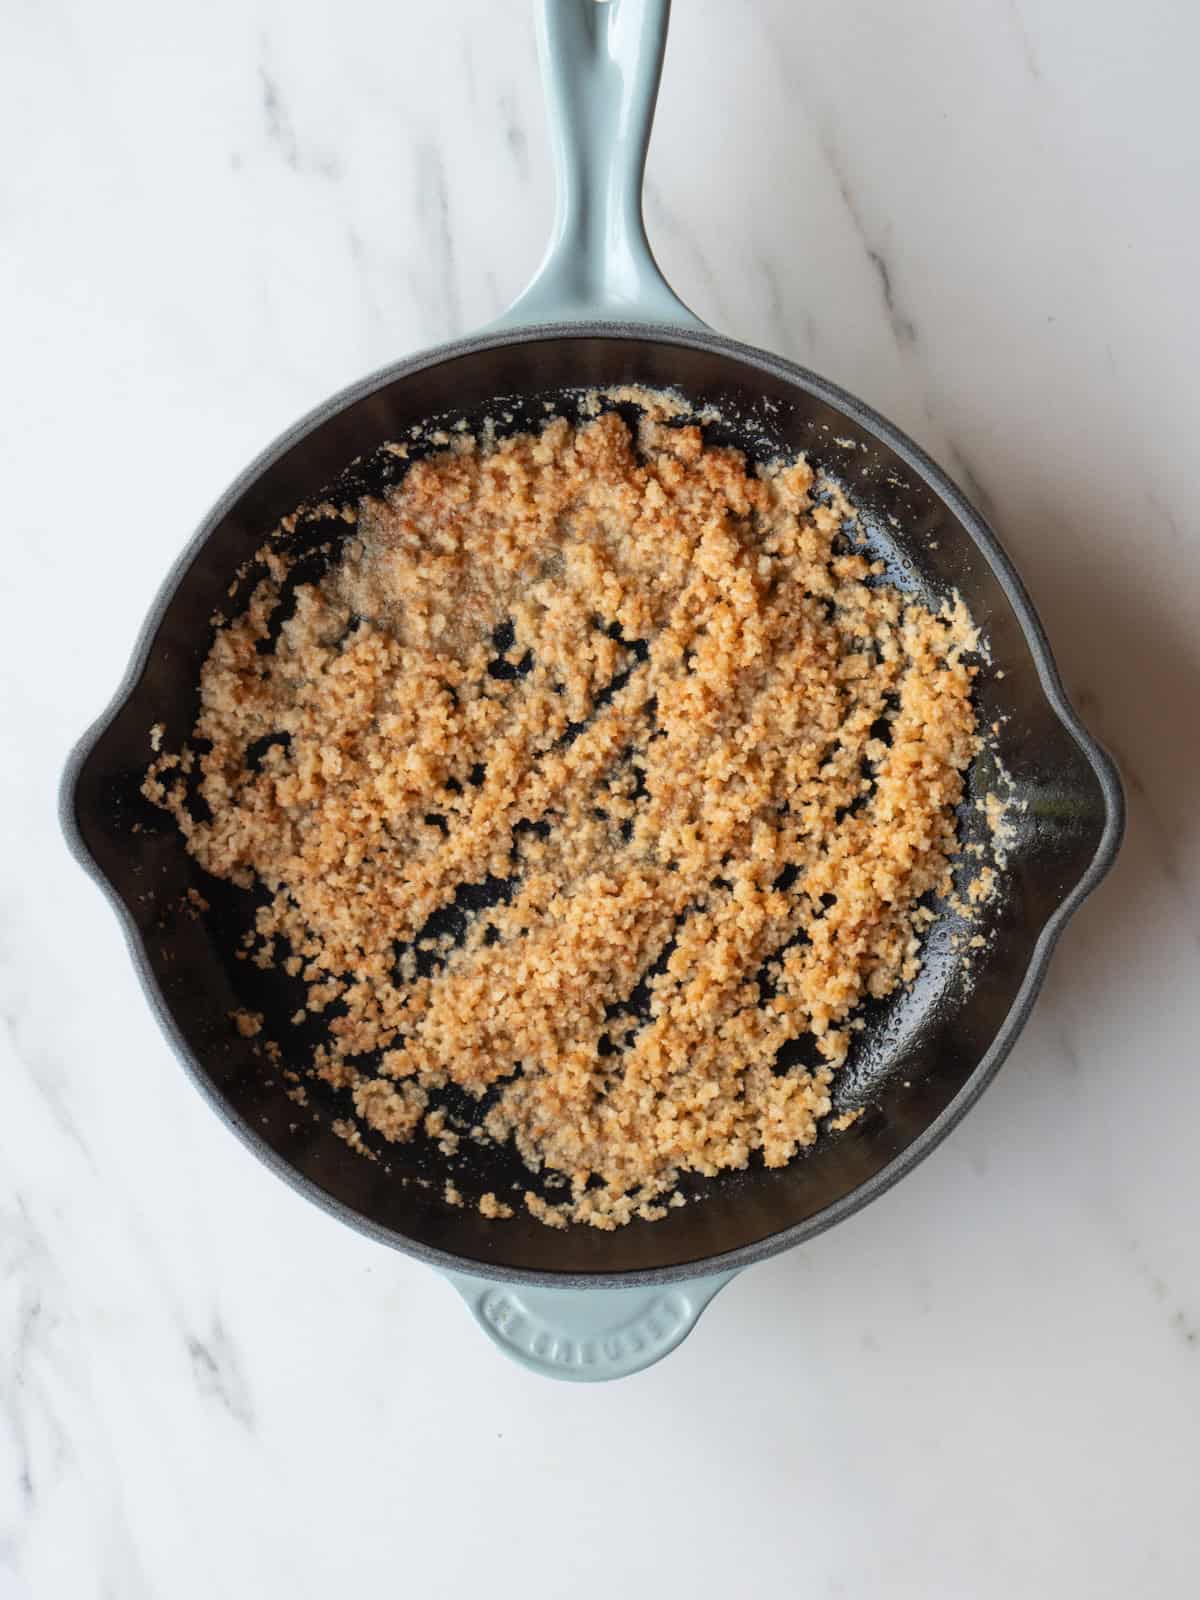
[144,413,978,1227]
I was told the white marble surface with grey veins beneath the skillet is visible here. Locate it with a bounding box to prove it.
[0,0,1200,1600]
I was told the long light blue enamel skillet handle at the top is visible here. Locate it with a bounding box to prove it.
[490,0,704,331]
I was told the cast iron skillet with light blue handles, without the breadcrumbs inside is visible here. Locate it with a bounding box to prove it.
[62,0,1122,1378]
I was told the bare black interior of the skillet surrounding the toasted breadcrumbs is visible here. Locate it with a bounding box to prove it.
[67,333,1118,1275]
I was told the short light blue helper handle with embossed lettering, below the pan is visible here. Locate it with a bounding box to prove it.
[446,1270,736,1382]
